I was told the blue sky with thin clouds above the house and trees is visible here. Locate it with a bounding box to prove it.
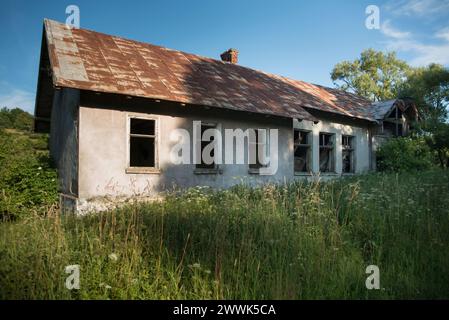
[0,0,449,112]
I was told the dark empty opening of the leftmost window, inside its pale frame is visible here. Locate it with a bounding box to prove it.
[129,118,156,168]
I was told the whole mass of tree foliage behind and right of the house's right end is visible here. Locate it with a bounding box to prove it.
[331,49,449,168]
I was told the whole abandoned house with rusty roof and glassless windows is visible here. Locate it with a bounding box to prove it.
[35,20,417,211]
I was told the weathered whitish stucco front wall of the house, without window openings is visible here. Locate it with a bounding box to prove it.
[79,106,370,205]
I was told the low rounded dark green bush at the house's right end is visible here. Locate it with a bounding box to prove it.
[376,137,435,172]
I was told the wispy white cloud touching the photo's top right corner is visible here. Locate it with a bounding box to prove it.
[384,0,449,17]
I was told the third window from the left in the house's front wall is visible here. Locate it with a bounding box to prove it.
[248,129,270,170]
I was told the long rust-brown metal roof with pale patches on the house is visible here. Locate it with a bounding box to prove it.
[44,19,374,121]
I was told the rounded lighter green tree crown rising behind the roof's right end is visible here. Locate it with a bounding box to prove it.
[331,49,411,101]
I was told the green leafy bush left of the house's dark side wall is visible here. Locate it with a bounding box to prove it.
[0,129,58,219]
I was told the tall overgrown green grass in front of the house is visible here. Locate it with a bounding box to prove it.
[0,171,449,299]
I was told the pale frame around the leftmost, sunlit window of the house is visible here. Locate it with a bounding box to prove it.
[125,114,160,174]
